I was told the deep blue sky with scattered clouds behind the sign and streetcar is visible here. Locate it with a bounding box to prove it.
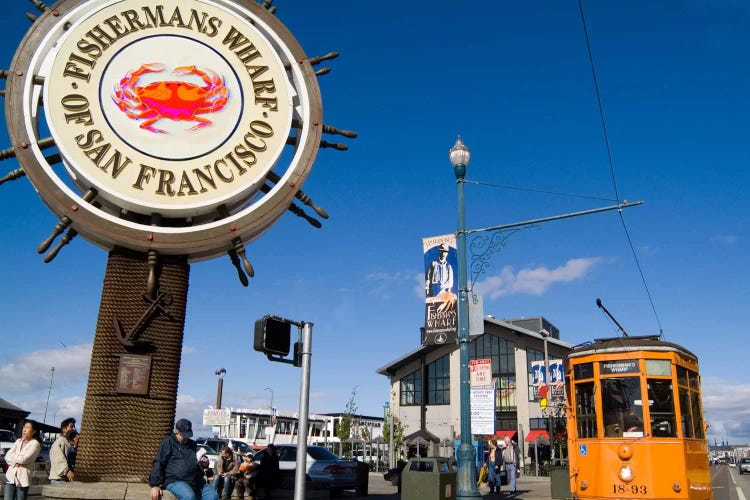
[0,0,750,443]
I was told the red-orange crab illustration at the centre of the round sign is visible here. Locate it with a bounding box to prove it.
[112,63,229,134]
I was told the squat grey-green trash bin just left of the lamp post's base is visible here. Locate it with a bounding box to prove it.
[401,457,456,500]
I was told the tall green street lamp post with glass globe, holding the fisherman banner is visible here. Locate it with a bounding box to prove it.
[449,136,479,497]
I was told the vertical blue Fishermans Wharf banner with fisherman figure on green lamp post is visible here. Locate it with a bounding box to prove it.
[422,234,458,345]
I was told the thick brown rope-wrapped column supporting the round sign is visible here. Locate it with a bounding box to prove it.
[76,249,190,482]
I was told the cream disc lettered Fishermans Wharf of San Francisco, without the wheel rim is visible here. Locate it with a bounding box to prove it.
[45,1,293,215]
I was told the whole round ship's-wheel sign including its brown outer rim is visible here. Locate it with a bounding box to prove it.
[6,0,322,260]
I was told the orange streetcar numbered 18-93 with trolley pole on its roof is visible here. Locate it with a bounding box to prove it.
[565,336,713,500]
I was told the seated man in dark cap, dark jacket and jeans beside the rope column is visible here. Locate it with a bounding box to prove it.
[148,418,219,500]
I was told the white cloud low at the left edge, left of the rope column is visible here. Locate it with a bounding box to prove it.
[0,343,92,394]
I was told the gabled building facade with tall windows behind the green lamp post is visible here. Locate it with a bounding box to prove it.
[378,316,572,464]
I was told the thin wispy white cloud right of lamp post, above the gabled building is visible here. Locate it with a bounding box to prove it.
[474,257,602,299]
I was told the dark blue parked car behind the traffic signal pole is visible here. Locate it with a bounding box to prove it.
[253,444,358,493]
